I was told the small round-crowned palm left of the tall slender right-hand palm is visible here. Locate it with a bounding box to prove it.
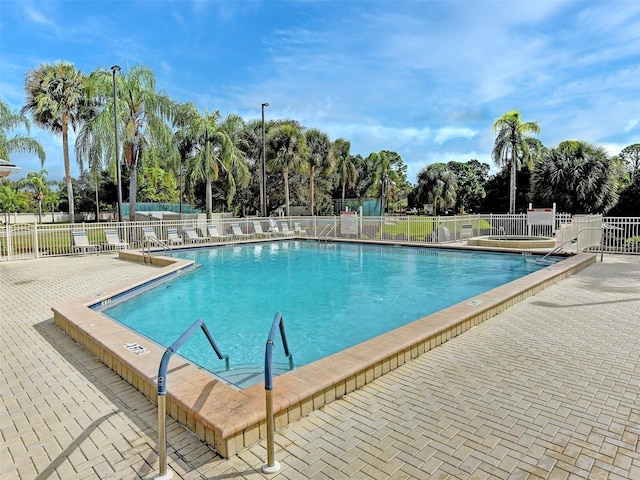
[416,163,458,215]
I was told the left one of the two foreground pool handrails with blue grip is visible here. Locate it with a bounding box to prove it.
[156,320,229,480]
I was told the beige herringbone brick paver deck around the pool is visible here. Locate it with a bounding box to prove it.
[0,255,640,480]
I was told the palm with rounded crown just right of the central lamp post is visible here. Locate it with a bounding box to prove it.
[268,122,309,216]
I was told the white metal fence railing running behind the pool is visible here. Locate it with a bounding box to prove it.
[0,213,640,261]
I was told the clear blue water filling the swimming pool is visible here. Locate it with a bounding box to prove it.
[104,240,545,388]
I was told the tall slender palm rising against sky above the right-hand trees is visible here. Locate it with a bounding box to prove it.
[492,110,540,213]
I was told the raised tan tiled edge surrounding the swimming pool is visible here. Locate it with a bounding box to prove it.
[53,248,596,457]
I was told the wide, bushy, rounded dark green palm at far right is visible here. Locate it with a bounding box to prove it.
[532,141,619,214]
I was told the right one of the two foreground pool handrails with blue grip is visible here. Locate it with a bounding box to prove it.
[262,312,293,473]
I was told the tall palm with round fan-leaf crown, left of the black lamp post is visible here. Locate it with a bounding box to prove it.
[22,62,86,223]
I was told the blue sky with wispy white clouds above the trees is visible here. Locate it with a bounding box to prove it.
[0,0,640,182]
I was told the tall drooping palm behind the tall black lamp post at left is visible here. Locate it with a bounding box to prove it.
[78,65,178,220]
